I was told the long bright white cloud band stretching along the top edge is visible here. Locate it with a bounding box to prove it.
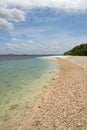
[3,0,87,11]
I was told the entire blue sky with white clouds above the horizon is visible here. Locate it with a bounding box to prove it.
[0,0,87,54]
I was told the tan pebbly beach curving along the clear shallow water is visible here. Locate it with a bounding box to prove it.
[15,56,87,130]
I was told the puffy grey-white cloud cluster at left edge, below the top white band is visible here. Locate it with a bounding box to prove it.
[0,2,25,30]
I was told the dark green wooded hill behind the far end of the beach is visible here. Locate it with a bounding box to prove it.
[64,43,87,56]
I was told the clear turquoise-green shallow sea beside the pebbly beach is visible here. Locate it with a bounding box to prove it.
[0,56,59,130]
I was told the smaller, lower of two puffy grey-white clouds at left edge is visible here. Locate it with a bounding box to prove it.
[0,18,13,30]
